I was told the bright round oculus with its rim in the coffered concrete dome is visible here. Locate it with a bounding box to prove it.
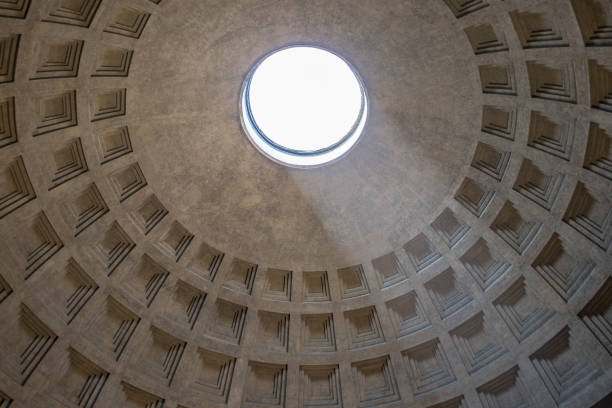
[241,46,367,167]
